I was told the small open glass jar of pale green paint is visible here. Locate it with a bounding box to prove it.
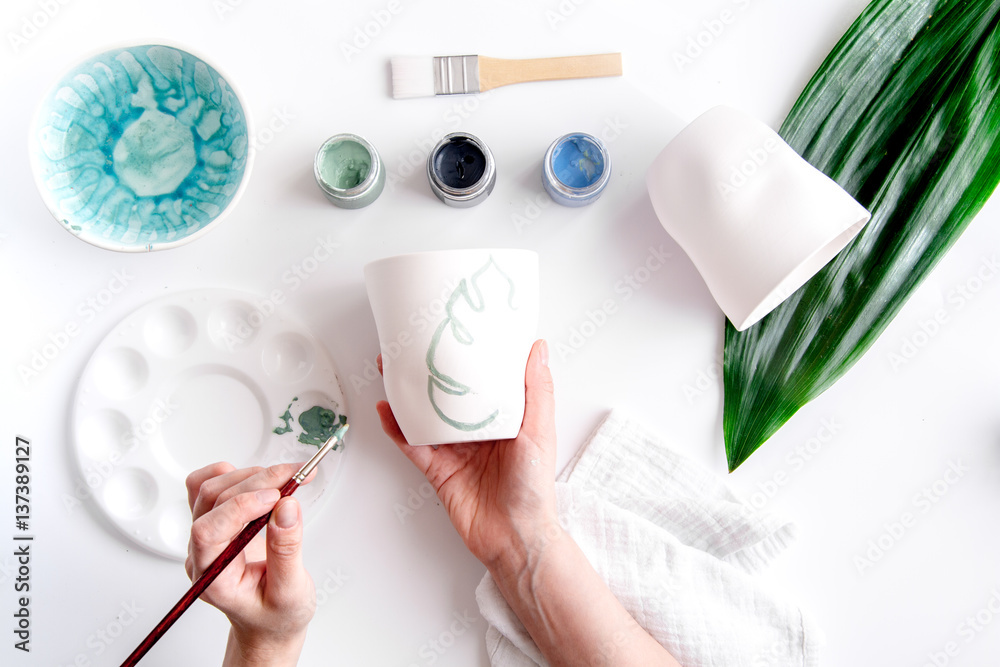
[313,133,385,208]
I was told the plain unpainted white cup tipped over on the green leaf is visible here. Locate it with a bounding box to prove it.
[646,107,871,331]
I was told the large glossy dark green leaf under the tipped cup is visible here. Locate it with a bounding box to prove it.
[723,0,1000,471]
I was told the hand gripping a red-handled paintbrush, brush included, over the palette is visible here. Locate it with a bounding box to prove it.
[122,424,347,667]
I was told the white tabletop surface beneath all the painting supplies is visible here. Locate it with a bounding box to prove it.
[0,0,1000,667]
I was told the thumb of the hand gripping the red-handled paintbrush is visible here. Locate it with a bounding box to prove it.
[266,497,305,605]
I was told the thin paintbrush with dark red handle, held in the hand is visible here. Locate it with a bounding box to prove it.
[122,424,348,667]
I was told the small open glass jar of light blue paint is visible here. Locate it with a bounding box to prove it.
[542,132,611,206]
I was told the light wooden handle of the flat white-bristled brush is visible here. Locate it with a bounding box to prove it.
[479,53,622,91]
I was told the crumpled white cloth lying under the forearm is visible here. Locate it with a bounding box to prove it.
[476,412,822,667]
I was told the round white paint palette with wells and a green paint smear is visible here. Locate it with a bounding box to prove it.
[73,289,347,560]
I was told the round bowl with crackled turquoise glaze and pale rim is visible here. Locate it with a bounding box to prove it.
[29,44,251,252]
